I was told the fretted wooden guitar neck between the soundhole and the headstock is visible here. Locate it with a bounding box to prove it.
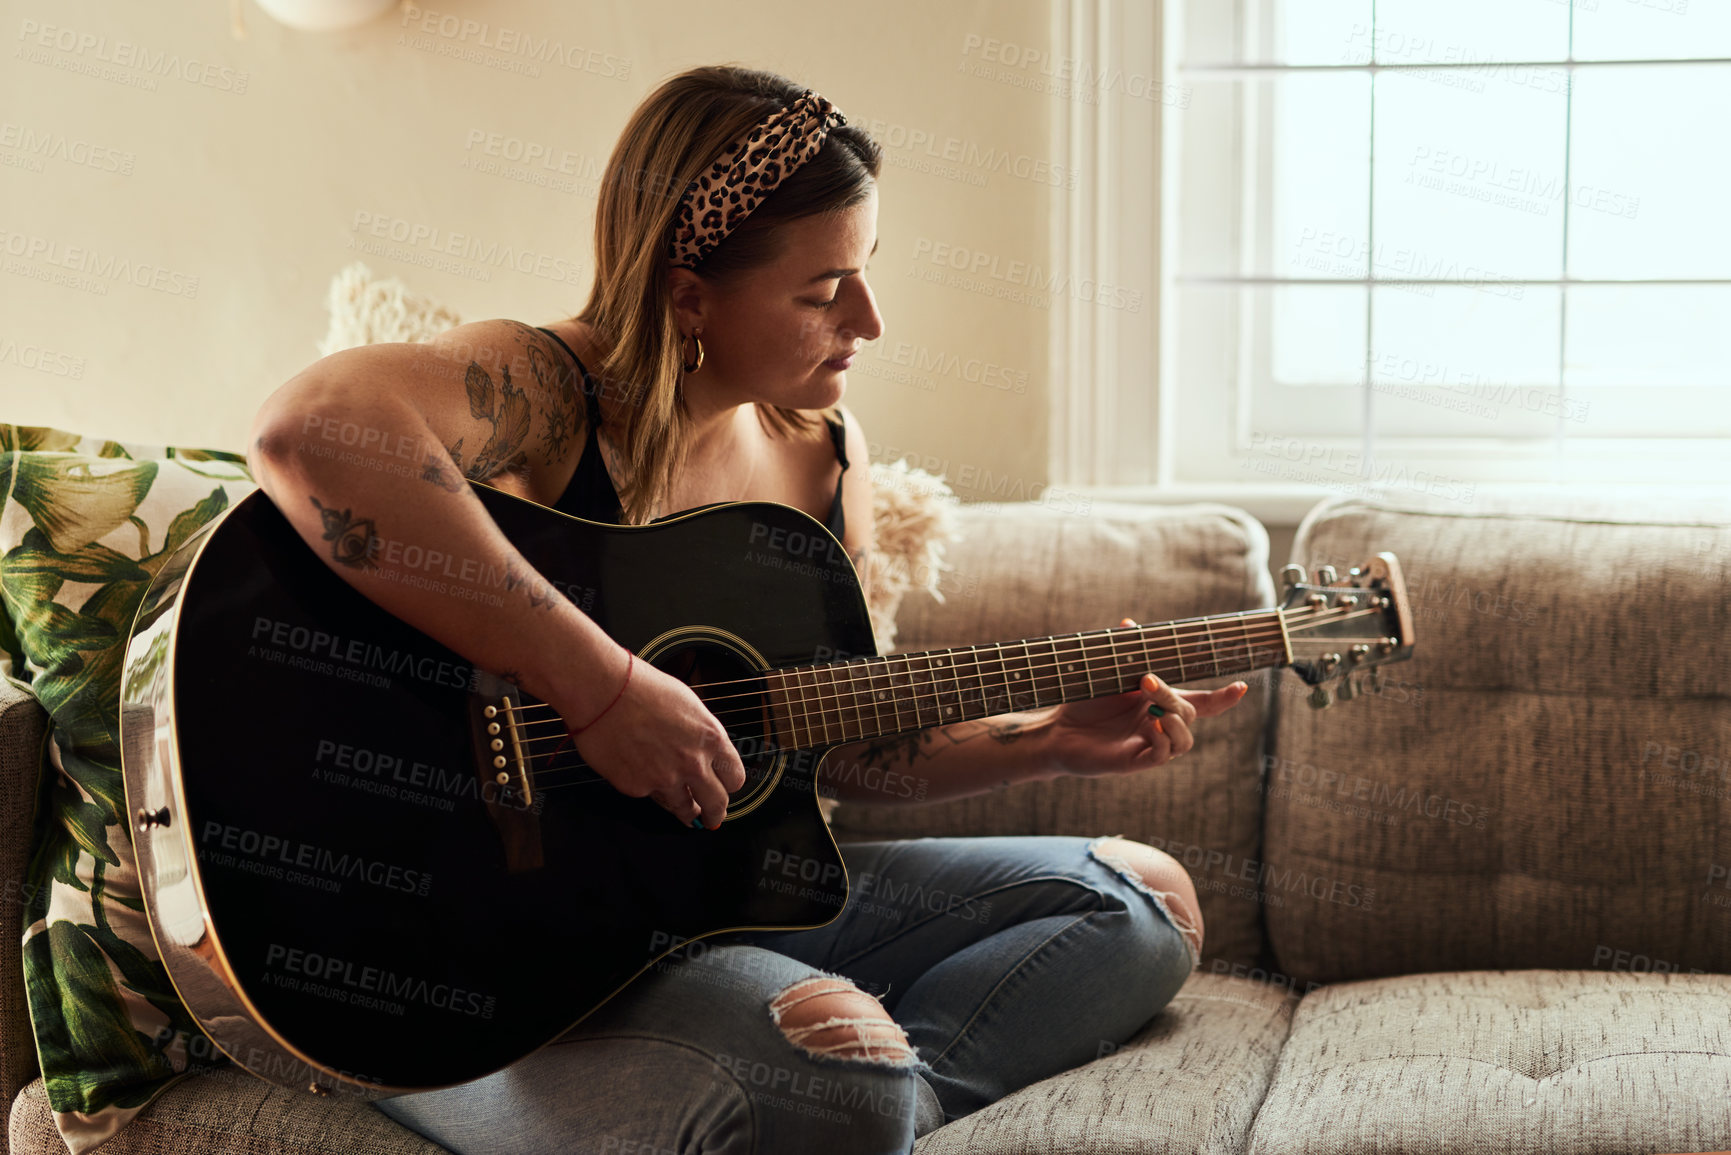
[765,610,1290,750]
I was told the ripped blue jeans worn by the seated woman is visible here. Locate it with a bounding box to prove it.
[374,836,1198,1155]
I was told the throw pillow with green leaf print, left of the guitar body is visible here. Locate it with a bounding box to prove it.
[0,426,254,1155]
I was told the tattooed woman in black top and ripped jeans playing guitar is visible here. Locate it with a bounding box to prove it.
[253,68,1245,1155]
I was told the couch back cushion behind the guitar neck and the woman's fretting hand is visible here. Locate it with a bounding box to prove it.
[836,502,1290,966]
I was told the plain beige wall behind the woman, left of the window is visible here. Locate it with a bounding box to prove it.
[0,0,1059,499]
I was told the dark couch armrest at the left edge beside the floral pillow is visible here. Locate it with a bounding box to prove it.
[0,679,48,1155]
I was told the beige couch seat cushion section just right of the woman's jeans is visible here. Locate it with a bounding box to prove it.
[914,975,1298,1155]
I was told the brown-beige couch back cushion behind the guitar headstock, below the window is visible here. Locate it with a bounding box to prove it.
[1260,490,1731,982]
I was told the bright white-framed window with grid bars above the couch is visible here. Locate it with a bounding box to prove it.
[1162,0,1731,495]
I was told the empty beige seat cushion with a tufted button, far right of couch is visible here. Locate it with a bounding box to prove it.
[1250,971,1731,1155]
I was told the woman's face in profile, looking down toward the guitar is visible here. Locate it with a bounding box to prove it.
[675,187,883,409]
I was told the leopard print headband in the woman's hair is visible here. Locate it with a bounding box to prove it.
[668,88,848,268]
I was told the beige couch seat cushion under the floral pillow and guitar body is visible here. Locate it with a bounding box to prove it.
[12,1067,448,1155]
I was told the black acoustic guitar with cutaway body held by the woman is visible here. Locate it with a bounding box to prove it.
[121,483,1414,1096]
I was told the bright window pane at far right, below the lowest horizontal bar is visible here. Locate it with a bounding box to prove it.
[1563,284,1731,387]
